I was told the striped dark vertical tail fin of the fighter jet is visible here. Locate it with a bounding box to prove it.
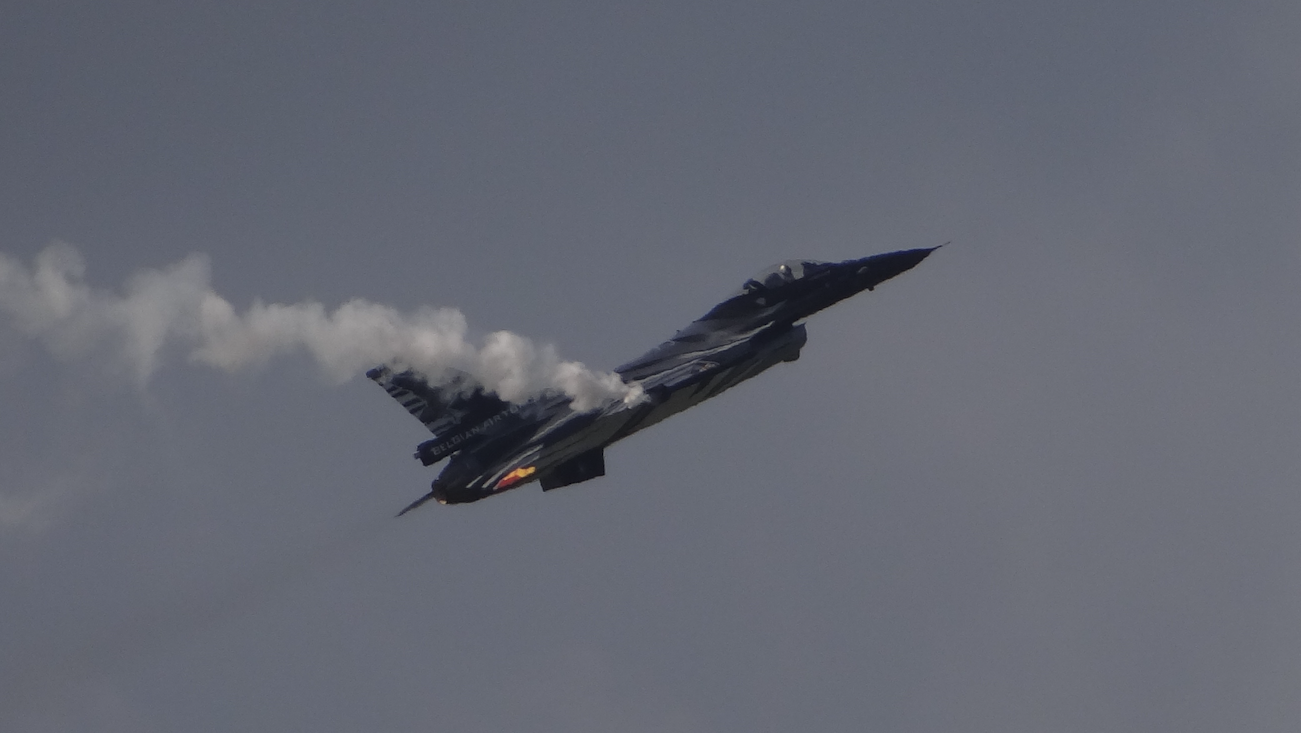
[366,366,510,462]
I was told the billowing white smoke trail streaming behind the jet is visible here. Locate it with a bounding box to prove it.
[0,242,640,410]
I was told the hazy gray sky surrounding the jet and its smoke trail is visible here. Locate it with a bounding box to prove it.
[0,1,1301,733]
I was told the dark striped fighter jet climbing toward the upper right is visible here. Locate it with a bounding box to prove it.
[366,247,938,517]
